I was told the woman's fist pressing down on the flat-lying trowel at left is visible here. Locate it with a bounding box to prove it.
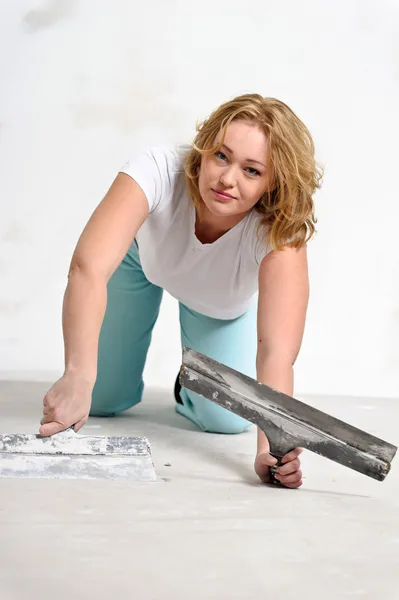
[39,374,93,436]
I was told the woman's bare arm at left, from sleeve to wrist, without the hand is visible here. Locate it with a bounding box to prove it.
[63,173,148,379]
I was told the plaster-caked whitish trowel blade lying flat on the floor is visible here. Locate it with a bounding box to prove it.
[0,429,156,482]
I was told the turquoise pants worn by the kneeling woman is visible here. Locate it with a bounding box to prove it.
[90,243,257,433]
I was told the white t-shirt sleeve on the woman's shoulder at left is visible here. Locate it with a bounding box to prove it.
[120,146,181,213]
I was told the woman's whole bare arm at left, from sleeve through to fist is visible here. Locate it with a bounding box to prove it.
[40,173,149,435]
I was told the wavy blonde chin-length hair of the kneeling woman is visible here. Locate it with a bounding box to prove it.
[184,94,323,250]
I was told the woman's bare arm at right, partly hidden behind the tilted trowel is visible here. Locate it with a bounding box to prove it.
[256,246,309,486]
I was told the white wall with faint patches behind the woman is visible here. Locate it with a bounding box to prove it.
[0,0,399,397]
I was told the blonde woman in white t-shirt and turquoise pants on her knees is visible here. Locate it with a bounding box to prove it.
[40,94,321,488]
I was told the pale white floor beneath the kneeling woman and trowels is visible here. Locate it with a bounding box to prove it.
[0,382,399,600]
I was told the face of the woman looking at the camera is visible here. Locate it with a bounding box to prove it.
[198,120,269,217]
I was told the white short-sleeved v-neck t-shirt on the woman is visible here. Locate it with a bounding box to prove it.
[121,147,270,319]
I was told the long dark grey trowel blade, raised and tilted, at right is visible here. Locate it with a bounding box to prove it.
[180,347,397,481]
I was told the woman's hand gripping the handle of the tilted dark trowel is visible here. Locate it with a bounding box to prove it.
[255,448,302,488]
